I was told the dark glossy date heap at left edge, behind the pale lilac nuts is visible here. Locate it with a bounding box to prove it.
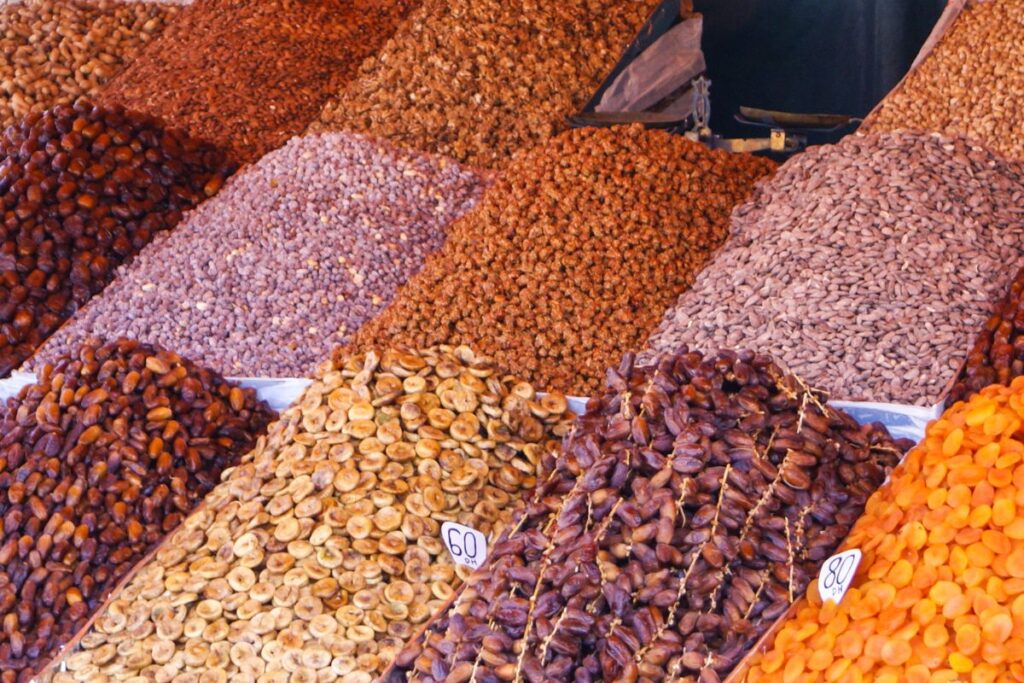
[0,100,234,377]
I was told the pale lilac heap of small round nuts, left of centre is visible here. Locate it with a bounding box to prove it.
[32,133,482,377]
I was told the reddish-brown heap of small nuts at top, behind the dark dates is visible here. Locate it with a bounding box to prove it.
[98,0,420,163]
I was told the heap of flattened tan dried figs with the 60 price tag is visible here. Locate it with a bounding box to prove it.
[52,347,573,683]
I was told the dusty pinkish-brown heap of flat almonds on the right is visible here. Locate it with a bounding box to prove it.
[649,132,1024,405]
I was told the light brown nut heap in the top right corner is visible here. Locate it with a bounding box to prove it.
[862,0,1024,159]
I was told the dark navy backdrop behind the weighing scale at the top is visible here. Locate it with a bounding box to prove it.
[693,0,945,137]
